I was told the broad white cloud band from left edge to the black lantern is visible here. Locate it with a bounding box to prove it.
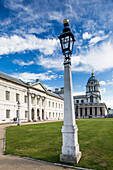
[0,35,59,55]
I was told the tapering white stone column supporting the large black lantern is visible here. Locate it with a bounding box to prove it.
[60,61,81,163]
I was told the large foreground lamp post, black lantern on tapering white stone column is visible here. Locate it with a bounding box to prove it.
[58,19,81,163]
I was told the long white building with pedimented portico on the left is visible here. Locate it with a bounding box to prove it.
[0,72,64,123]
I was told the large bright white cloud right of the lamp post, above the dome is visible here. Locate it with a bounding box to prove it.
[72,41,113,72]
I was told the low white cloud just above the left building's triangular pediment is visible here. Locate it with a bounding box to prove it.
[12,72,57,82]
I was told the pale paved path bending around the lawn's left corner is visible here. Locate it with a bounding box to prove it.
[0,121,80,170]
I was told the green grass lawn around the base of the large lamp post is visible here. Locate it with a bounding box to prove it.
[5,119,113,170]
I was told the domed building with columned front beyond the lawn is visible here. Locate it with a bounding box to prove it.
[74,71,107,118]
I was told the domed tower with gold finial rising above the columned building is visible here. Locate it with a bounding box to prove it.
[86,70,101,103]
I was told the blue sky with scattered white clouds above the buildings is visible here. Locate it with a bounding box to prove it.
[0,0,113,108]
